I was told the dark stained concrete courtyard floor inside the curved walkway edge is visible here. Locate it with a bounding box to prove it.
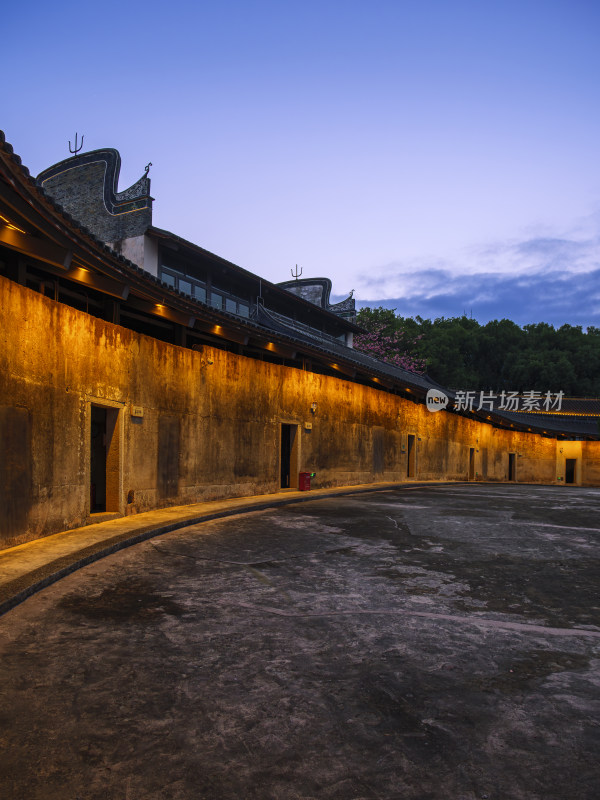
[0,484,600,800]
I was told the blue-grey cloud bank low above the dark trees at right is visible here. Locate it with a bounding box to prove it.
[357,225,600,327]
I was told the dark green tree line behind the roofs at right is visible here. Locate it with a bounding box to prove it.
[355,307,600,397]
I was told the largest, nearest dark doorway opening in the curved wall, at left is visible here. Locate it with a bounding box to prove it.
[90,404,120,514]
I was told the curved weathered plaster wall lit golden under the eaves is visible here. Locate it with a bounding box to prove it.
[0,279,600,546]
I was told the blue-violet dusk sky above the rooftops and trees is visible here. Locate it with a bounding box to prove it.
[0,0,600,328]
